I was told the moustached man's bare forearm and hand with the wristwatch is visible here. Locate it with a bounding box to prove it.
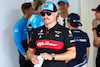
[40,47,76,61]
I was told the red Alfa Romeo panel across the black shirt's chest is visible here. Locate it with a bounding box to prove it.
[35,39,64,49]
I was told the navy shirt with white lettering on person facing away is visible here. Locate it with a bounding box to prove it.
[66,29,90,67]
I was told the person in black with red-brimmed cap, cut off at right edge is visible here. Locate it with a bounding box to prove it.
[92,4,100,67]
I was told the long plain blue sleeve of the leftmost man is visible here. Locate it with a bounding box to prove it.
[14,24,25,53]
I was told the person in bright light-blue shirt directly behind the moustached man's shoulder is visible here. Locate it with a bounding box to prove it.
[27,0,46,44]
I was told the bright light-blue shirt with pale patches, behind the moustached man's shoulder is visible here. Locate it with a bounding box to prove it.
[27,14,44,37]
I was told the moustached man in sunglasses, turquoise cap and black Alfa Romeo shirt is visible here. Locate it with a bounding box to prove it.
[27,2,76,67]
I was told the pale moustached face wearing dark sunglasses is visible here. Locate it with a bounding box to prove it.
[40,11,56,25]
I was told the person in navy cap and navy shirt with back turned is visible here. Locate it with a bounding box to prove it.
[66,13,90,67]
